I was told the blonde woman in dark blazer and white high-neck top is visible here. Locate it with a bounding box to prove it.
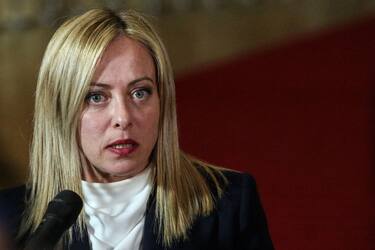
[0,10,273,249]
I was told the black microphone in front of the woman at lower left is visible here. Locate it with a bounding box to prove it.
[25,190,83,250]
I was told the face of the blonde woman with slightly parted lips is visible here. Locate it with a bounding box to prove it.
[80,35,160,182]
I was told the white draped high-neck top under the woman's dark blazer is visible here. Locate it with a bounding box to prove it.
[82,166,152,250]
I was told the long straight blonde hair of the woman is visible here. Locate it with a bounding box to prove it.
[19,9,225,246]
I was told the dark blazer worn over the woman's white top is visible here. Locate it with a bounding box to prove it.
[0,171,274,250]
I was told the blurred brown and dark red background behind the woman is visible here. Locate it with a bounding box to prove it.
[0,0,375,250]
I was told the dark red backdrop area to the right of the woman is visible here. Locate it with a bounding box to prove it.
[176,16,375,250]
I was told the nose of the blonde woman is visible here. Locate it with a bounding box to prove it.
[112,100,132,130]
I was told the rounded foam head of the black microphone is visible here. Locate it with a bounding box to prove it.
[44,190,83,230]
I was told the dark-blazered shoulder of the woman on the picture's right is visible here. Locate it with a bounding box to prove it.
[195,168,274,250]
